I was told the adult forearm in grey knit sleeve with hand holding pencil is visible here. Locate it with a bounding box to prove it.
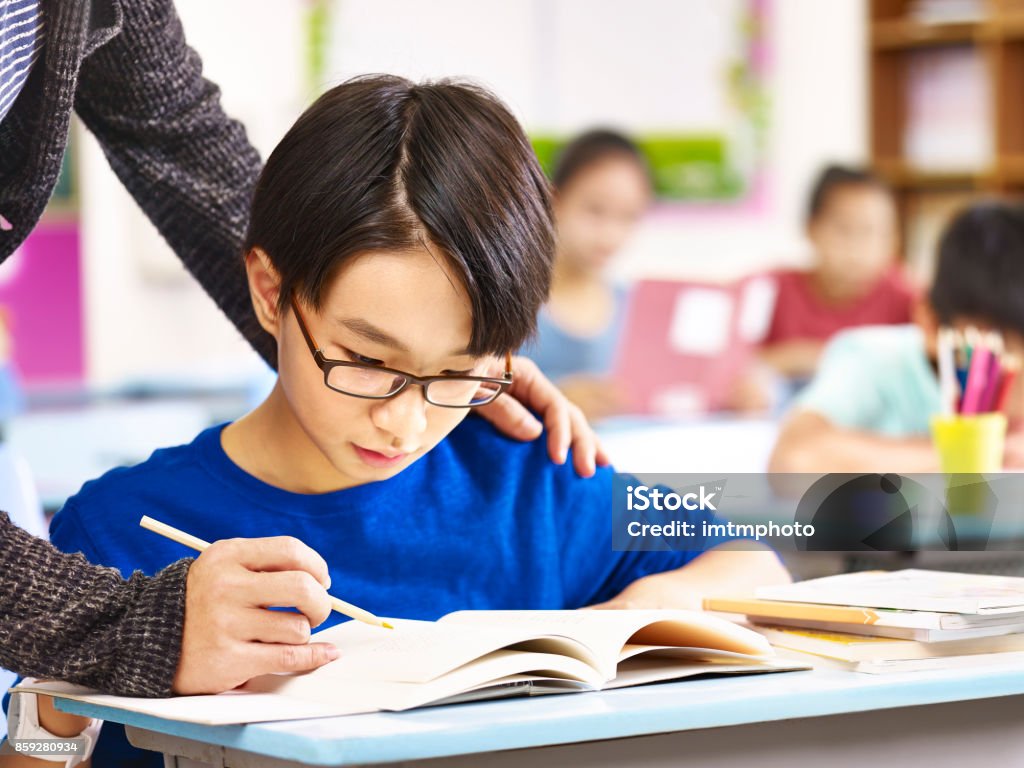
[0,513,337,696]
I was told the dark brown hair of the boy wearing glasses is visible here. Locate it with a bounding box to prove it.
[245,75,554,355]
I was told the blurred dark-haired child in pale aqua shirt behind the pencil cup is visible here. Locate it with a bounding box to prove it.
[770,203,1024,472]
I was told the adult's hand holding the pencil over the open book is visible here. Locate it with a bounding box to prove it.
[174,537,338,694]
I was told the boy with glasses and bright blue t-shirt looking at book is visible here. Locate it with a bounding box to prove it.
[25,77,787,765]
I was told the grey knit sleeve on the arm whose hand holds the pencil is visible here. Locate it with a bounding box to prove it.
[0,512,193,696]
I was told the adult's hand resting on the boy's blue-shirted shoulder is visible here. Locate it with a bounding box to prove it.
[477,357,608,477]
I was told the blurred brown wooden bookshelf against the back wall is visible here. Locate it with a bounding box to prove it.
[867,0,1024,279]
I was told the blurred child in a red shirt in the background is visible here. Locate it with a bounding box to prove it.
[762,166,912,380]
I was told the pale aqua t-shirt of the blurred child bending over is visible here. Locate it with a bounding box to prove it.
[795,326,942,437]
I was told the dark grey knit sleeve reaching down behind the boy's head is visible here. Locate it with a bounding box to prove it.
[75,0,276,365]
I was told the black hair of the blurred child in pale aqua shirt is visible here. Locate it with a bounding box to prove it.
[929,202,1024,333]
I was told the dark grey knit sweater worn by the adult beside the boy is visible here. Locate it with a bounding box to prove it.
[0,0,273,695]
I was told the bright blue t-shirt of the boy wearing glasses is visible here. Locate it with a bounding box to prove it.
[36,416,724,767]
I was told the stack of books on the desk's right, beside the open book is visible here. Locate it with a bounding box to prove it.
[705,569,1024,674]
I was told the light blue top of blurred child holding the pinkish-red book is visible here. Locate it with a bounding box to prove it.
[521,286,629,381]
